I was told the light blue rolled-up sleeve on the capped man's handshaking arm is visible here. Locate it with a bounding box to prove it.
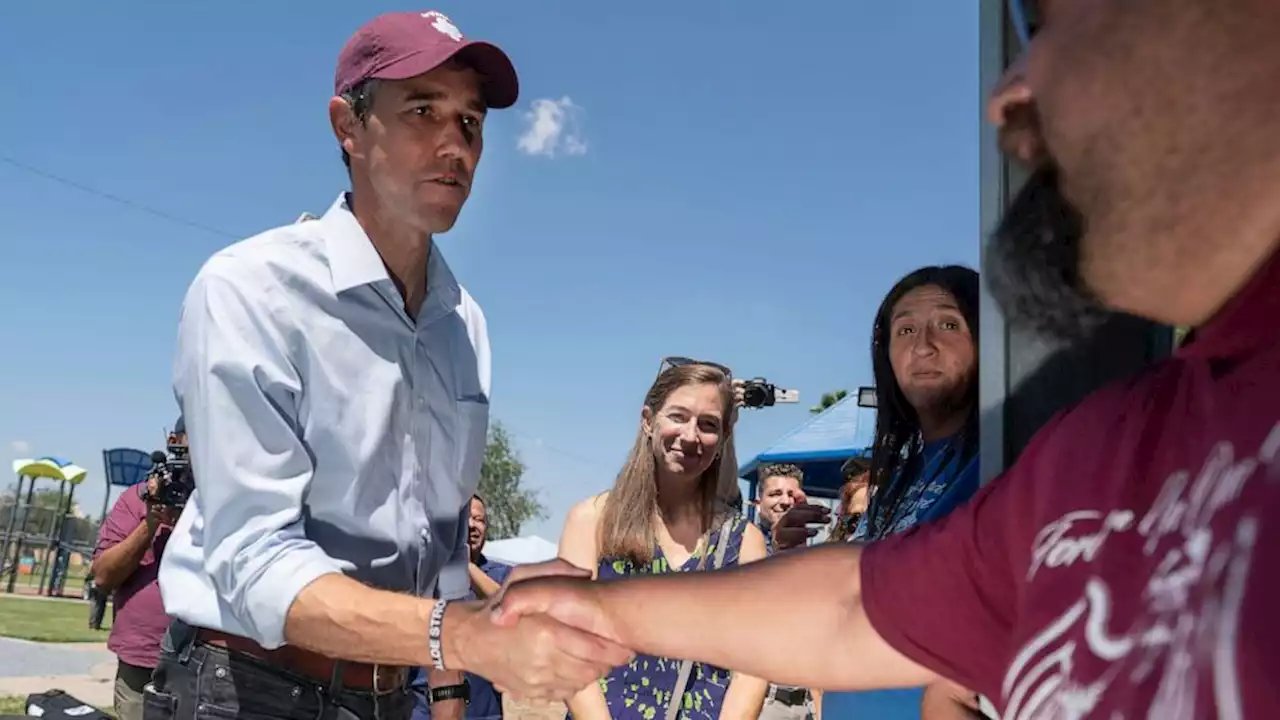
[174,256,343,648]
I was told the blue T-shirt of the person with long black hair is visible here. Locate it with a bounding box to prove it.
[822,438,980,720]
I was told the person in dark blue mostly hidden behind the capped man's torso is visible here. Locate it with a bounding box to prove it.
[410,495,513,720]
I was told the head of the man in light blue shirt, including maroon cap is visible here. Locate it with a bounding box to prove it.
[329,10,520,238]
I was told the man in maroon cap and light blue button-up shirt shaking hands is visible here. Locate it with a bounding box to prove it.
[145,12,630,720]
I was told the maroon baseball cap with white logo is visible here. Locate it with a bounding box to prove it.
[333,10,520,109]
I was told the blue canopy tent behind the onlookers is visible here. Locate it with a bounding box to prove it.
[737,393,876,502]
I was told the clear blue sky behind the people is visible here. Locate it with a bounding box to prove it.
[0,0,980,539]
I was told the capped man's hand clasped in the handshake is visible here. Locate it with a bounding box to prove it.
[444,594,632,701]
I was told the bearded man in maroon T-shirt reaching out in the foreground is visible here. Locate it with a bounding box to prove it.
[497,0,1280,720]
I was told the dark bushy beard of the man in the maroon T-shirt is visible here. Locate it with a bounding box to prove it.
[983,164,1111,342]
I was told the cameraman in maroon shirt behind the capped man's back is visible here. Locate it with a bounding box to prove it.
[90,418,186,720]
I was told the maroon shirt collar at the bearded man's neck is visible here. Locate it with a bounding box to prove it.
[1178,250,1280,357]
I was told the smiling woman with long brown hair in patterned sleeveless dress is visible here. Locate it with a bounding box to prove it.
[559,359,768,720]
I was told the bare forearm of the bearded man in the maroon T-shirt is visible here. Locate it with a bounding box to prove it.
[599,543,928,689]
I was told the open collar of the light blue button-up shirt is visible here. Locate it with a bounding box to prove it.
[320,192,462,319]
